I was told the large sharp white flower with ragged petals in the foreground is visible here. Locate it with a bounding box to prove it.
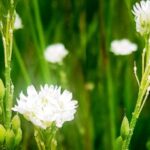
[12,84,77,129]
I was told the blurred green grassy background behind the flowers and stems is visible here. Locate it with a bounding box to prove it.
[0,0,150,150]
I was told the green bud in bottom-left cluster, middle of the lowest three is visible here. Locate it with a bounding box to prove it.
[5,129,15,149]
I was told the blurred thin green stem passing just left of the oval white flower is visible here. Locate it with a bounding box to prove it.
[106,0,116,150]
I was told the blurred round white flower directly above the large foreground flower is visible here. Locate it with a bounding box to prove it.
[44,43,68,63]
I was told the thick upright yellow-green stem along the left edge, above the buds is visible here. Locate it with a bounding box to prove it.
[2,10,14,128]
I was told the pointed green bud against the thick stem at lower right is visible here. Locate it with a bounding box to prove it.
[120,116,130,140]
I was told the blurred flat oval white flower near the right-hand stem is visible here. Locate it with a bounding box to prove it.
[111,39,137,55]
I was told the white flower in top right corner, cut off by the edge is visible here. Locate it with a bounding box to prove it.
[132,0,150,35]
